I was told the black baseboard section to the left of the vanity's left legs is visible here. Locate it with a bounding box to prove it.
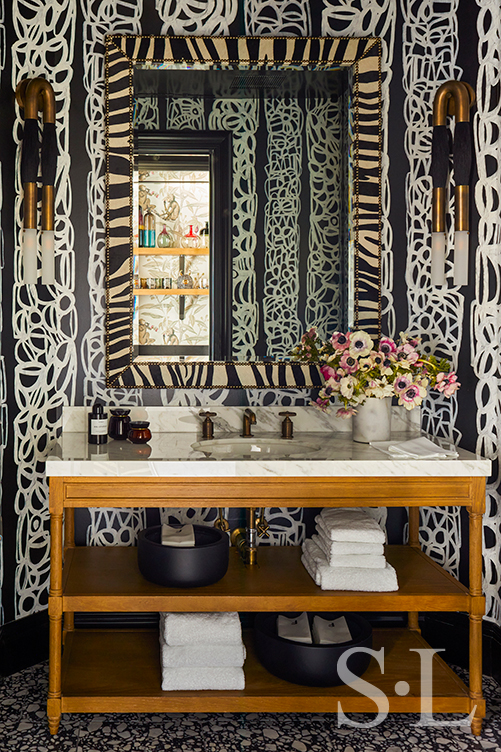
[0,611,49,676]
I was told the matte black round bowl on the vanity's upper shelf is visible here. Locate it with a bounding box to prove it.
[137,525,229,587]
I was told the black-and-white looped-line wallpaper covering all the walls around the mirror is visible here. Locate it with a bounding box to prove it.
[0,0,501,636]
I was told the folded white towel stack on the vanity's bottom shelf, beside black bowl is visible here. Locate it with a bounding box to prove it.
[160,612,245,690]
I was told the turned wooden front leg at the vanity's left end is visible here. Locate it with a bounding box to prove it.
[47,500,63,734]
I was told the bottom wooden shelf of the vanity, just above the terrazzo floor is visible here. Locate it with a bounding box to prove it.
[61,629,469,713]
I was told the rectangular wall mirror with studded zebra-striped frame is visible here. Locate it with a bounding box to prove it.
[106,35,381,388]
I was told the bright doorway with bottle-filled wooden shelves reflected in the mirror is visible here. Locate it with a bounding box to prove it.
[133,154,210,361]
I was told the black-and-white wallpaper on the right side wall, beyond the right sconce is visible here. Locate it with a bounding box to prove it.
[471,0,501,624]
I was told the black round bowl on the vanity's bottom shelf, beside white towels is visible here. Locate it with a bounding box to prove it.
[254,613,372,687]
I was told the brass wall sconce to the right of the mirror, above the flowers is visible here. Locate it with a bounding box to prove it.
[431,81,475,285]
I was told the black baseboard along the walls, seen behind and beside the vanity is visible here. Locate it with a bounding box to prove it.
[0,611,501,684]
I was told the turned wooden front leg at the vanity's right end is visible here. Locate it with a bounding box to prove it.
[468,478,485,735]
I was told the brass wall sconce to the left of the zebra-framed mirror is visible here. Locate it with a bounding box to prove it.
[16,78,57,285]
